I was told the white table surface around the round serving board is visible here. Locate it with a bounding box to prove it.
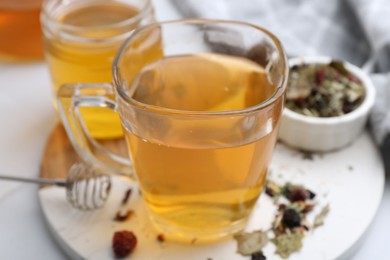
[0,0,390,260]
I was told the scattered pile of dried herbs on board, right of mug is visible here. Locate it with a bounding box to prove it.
[235,181,330,259]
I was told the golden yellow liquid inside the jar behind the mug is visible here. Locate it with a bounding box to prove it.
[44,1,158,139]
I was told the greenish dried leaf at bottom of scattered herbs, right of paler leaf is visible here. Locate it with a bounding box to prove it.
[271,232,304,258]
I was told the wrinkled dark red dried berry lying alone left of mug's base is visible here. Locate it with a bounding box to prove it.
[112,230,137,258]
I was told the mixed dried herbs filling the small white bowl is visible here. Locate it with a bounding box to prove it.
[286,61,365,117]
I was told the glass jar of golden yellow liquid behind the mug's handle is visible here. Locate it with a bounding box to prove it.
[41,0,155,139]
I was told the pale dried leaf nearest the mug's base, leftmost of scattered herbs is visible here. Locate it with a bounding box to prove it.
[234,231,268,256]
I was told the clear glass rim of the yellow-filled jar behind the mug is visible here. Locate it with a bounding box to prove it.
[41,0,154,43]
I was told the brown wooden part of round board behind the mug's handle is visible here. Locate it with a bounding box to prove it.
[40,124,127,179]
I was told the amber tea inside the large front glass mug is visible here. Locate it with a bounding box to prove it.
[126,54,282,241]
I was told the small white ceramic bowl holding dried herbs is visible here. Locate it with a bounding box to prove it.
[279,56,375,152]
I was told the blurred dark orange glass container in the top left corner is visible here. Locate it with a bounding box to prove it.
[0,0,43,62]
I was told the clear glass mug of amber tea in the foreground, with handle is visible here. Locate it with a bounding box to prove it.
[59,20,288,241]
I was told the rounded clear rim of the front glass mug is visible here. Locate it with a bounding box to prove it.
[112,19,289,116]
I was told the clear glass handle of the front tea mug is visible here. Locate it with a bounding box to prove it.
[57,83,135,180]
